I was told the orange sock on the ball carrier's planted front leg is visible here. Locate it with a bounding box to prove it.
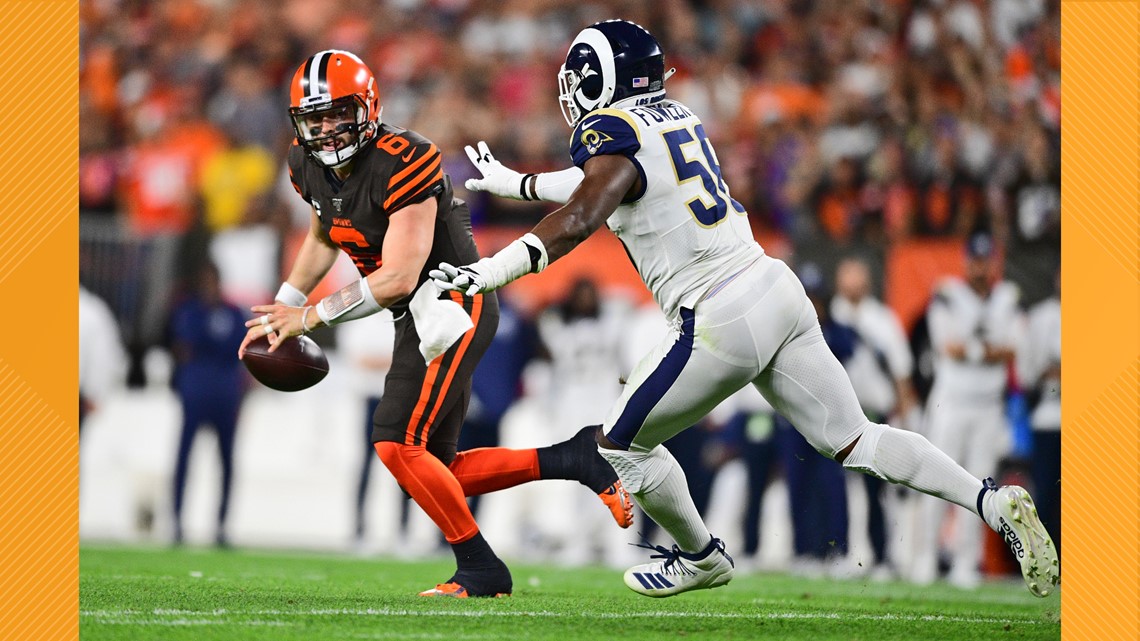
[373,440,479,543]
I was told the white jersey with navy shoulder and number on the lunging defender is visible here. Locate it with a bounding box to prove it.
[570,99,764,319]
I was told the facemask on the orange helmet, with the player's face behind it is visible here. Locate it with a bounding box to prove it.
[290,96,375,168]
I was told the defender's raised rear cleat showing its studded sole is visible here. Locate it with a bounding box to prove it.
[986,485,1060,597]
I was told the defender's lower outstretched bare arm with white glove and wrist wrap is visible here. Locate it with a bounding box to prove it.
[431,155,641,295]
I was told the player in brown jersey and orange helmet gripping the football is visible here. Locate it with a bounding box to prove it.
[238,50,633,598]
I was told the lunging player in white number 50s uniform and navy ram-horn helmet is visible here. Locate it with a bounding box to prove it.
[432,21,1058,597]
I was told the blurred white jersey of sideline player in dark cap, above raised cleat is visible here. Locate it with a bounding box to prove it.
[929,278,1020,401]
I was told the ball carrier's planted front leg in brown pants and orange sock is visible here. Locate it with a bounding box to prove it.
[372,294,511,598]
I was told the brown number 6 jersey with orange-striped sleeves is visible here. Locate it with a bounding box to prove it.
[288,124,479,315]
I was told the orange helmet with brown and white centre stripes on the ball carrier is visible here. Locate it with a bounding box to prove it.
[288,49,381,167]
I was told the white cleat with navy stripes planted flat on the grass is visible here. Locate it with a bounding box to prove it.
[622,538,735,598]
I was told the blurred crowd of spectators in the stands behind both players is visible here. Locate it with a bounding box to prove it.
[80,0,1060,281]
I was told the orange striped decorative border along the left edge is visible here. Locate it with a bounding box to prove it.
[0,0,79,641]
